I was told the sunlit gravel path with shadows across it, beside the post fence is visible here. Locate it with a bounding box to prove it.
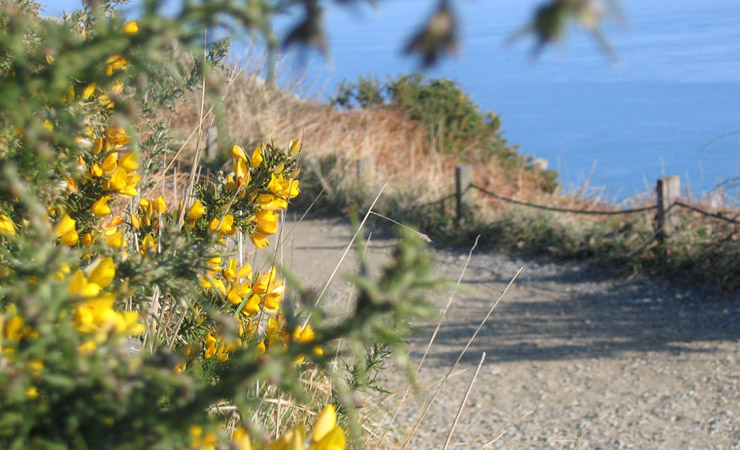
[272,216,740,449]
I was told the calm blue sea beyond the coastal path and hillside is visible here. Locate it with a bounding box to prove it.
[43,0,740,200]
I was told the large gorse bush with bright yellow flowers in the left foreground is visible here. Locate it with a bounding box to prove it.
[0,1,439,449]
